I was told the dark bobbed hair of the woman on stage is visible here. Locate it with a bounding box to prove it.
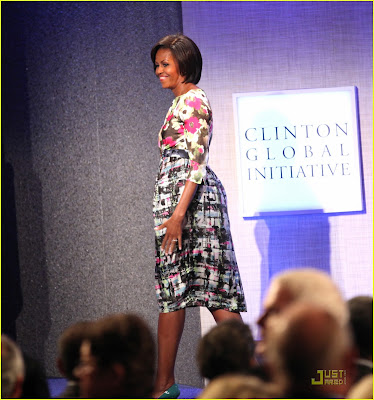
[151,34,203,84]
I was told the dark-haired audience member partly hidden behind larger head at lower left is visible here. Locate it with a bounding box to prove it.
[57,321,92,399]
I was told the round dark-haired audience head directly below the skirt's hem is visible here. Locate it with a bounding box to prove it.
[197,319,254,379]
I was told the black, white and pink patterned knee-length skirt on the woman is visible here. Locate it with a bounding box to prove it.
[153,155,246,313]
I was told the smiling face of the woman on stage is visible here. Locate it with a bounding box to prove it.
[155,48,184,96]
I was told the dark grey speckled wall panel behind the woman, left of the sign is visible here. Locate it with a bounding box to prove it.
[2,2,201,385]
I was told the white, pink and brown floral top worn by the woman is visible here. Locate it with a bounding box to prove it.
[158,89,213,184]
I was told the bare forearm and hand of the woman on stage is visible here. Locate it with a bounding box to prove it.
[155,181,198,254]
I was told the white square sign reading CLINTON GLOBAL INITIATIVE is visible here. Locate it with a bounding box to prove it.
[233,87,363,217]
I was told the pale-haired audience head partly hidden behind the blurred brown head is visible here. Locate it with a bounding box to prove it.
[257,268,348,353]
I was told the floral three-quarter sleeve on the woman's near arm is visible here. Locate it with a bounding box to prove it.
[178,92,212,184]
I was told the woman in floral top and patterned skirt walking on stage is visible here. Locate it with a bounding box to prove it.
[151,35,246,398]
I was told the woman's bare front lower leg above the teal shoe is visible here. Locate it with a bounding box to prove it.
[153,309,186,398]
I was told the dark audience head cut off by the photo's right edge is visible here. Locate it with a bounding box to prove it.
[348,296,373,361]
